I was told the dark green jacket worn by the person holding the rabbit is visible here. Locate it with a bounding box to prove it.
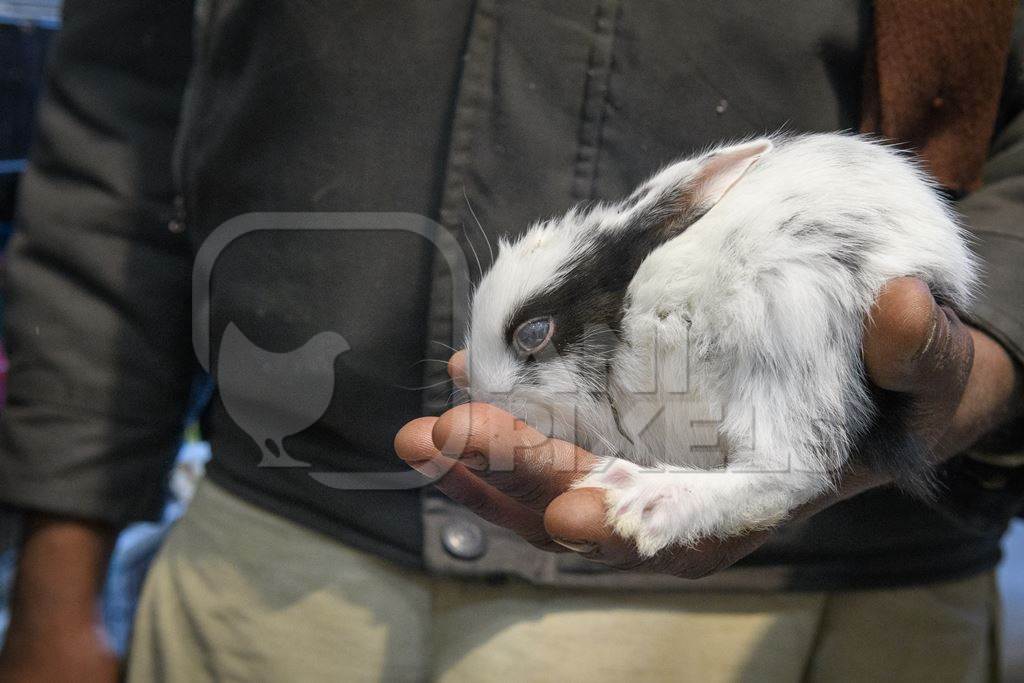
[0,0,1024,588]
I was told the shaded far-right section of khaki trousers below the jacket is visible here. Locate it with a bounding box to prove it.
[807,572,999,683]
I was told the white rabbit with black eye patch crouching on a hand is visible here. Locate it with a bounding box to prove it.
[466,134,976,555]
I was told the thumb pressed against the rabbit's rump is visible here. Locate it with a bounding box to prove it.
[863,278,974,398]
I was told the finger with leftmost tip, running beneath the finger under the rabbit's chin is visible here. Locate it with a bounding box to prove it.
[394,418,552,550]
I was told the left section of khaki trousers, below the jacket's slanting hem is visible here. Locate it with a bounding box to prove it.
[128,481,430,682]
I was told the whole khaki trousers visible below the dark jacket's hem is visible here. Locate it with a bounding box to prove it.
[128,481,998,683]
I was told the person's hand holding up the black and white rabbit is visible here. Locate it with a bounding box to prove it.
[395,278,1018,578]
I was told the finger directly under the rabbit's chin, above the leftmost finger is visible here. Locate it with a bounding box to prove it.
[433,403,597,512]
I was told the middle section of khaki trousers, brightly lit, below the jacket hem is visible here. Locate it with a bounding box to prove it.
[433,581,825,683]
